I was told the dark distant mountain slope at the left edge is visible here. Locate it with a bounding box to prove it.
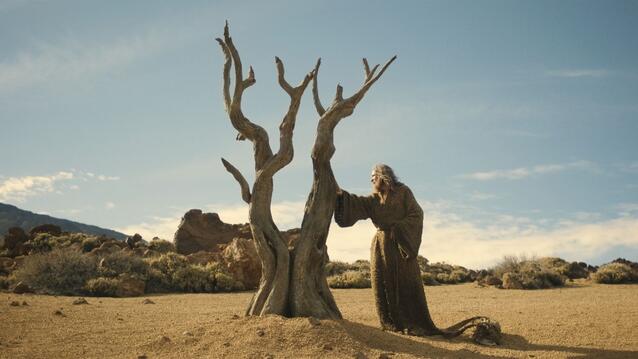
[0,203,127,240]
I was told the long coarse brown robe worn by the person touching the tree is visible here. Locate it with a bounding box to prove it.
[335,184,442,335]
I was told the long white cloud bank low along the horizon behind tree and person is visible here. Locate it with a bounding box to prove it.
[117,201,638,268]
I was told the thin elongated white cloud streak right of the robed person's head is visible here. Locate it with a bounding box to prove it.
[461,161,595,181]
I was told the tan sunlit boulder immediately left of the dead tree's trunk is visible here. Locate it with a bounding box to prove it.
[223,238,261,289]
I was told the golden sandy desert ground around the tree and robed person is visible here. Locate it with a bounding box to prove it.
[0,282,638,358]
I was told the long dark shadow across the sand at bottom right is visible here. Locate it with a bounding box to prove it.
[337,320,638,359]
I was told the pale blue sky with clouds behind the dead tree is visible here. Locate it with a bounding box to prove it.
[0,0,638,267]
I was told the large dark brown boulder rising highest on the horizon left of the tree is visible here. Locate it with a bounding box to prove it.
[174,209,252,255]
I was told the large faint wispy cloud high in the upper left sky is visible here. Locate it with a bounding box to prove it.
[0,31,171,92]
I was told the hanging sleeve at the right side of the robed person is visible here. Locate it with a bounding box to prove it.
[392,187,423,259]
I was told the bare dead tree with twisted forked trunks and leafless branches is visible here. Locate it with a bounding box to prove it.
[216,23,396,319]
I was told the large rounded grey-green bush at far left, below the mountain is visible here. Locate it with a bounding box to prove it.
[13,248,97,295]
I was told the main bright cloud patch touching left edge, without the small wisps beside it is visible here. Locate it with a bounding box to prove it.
[0,171,74,202]
